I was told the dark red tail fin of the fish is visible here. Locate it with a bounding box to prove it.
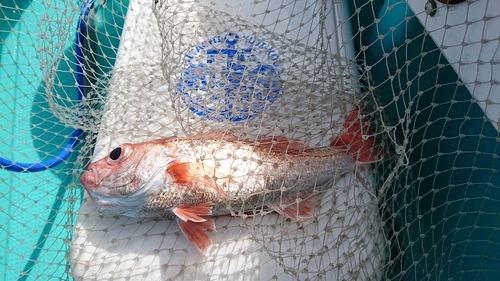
[331,107,383,163]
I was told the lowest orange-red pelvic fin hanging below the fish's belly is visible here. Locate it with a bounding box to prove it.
[177,218,215,252]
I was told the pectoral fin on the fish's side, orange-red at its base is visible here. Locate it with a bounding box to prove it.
[167,162,234,200]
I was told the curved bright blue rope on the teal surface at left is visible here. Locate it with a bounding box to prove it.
[0,0,95,172]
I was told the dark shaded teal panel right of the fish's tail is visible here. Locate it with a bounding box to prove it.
[352,0,500,280]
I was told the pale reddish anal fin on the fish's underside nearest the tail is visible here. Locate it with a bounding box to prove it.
[271,192,315,221]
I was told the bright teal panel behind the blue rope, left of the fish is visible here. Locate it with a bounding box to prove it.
[0,0,128,280]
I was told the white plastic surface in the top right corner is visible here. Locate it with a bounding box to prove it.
[407,0,500,130]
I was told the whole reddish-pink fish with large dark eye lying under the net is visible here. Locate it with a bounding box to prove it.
[80,108,386,249]
